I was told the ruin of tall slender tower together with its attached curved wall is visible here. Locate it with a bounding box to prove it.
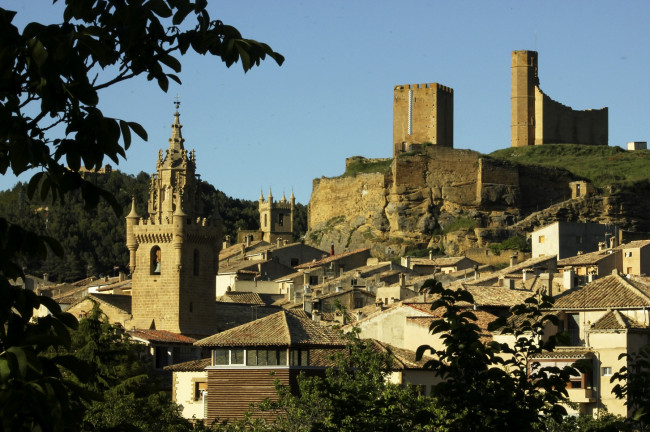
[511,51,608,147]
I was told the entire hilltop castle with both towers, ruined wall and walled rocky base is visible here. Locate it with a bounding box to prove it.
[308,51,608,258]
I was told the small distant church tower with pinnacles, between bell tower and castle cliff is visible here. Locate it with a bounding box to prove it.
[259,188,296,243]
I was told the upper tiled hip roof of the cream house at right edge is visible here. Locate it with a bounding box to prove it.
[553,275,650,309]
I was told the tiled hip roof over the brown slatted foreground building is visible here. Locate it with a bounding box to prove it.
[195,311,345,347]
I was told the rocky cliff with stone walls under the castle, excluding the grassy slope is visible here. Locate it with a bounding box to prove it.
[306,146,650,259]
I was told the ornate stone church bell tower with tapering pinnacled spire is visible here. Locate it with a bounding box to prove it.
[126,102,221,336]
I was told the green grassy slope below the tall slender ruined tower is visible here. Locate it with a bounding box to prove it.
[488,144,650,188]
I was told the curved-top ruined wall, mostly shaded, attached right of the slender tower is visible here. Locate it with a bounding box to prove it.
[535,87,608,146]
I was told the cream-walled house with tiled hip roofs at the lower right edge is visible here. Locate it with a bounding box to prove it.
[540,274,650,416]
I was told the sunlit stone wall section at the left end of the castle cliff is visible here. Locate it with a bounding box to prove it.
[308,173,387,229]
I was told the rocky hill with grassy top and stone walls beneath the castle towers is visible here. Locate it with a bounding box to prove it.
[306,144,650,261]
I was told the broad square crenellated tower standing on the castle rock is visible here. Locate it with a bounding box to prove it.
[393,83,454,157]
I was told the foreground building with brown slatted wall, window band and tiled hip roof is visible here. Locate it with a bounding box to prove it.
[191,311,345,424]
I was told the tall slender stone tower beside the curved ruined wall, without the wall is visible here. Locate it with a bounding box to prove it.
[510,51,539,147]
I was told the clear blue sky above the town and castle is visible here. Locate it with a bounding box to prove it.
[5,0,650,204]
